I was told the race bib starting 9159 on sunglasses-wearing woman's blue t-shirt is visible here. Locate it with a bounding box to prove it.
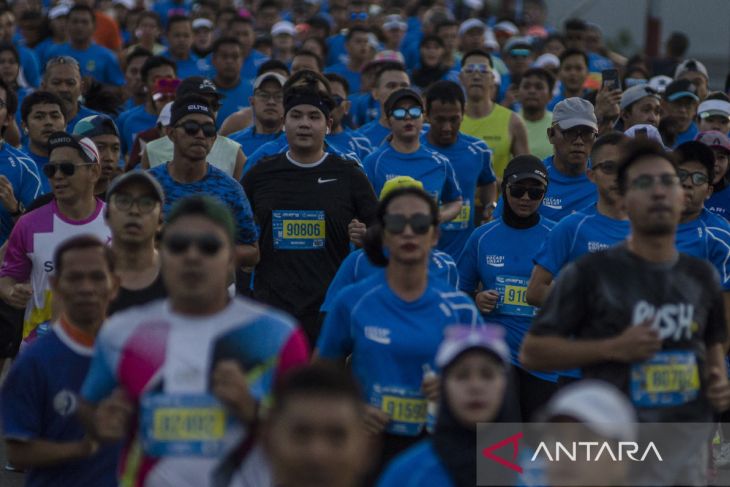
[371,387,427,436]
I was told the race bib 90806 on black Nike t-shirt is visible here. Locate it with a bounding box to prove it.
[271,210,327,250]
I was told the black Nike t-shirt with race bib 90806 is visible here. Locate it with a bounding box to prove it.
[243,154,378,317]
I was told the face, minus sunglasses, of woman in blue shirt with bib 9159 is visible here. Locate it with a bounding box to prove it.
[383,195,432,265]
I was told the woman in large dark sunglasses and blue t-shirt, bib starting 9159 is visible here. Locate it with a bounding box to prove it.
[317,187,482,472]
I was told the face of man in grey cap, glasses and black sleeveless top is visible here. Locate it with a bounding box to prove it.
[106,181,162,246]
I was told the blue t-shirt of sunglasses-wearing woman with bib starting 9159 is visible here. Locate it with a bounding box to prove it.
[317,272,482,436]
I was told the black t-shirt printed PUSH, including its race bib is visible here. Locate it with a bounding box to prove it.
[530,245,727,422]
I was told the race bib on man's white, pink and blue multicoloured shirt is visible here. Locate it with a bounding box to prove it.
[140,394,228,457]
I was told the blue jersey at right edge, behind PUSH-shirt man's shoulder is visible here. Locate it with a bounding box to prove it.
[676,209,730,291]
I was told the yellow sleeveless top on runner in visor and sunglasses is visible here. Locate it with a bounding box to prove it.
[460,104,512,179]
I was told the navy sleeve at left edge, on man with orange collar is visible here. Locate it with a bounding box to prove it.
[0,354,42,440]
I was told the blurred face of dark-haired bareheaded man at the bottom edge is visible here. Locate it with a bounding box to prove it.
[264,396,367,487]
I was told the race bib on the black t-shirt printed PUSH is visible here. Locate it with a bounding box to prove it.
[631,350,700,408]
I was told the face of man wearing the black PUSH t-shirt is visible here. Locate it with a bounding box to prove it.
[623,156,684,235]
